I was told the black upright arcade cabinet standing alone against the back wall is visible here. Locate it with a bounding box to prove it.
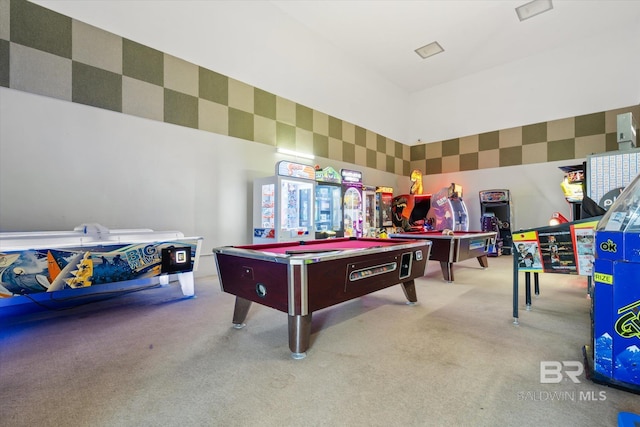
[479,189,513,256]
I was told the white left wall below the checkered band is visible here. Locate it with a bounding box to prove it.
[0,88,399,280]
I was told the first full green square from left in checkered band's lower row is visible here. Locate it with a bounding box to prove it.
[71,61,122,112]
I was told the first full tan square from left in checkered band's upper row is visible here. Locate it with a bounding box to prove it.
[71,19,122,74]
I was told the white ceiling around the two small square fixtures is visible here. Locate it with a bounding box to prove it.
[271,0,640,93]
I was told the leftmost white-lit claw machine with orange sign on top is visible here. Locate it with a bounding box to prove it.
[253,160,316,243]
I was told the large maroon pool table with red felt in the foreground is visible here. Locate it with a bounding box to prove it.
[213,237,431,359]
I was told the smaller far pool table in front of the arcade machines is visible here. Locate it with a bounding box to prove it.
[389,231,496,283]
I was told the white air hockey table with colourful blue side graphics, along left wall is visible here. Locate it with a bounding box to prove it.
[0,224,202,306]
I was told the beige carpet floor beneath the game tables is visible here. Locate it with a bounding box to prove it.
[0,256,640,427]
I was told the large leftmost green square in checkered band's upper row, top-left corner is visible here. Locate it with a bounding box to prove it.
[10,0,72,59]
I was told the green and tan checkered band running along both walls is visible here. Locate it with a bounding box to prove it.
[0,0,640,176]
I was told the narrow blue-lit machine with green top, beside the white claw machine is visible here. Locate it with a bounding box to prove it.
[315,166,344,239]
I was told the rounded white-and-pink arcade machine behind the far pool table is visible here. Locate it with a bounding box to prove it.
[427,183,469,231]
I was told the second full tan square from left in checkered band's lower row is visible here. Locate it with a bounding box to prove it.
[122,76,164,122]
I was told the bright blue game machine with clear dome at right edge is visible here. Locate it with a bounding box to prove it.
[584,175,640,393]
